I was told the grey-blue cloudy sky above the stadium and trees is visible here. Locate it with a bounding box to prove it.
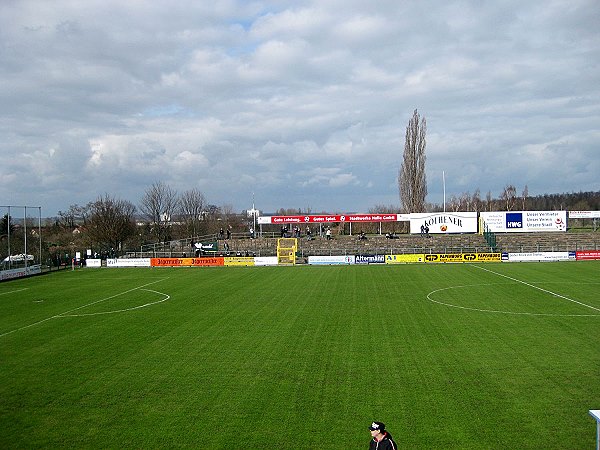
[0,0,600,216]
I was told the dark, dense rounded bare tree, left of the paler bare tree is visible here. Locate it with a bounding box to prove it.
[86,194,136,250]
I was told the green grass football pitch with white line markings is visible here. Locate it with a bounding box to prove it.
[0,262,600,449]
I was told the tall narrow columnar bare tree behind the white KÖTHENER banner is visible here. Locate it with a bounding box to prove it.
[398,109,427,213]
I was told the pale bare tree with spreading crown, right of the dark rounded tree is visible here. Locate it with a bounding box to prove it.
[140,181,179,242]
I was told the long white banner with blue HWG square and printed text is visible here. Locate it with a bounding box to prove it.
[481,211,567,233]
